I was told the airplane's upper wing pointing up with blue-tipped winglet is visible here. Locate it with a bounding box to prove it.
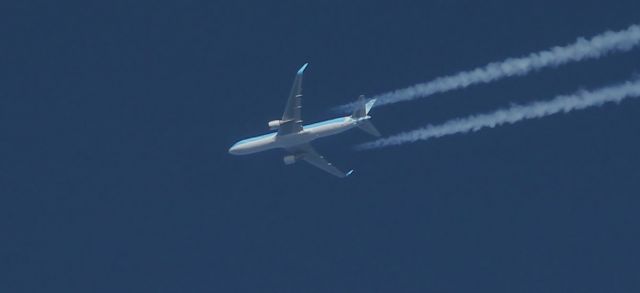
[278,63,309,135]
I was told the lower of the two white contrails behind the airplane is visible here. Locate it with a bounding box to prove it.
[356,79,640,150]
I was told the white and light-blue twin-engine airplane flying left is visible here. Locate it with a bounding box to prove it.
[229,63,380,178]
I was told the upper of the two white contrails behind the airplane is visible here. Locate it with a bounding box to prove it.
[334,25,640,112]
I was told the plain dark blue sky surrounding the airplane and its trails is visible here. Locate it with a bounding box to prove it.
[0,0,640,292]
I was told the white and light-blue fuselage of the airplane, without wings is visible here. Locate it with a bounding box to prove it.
[229,116,362,155]
